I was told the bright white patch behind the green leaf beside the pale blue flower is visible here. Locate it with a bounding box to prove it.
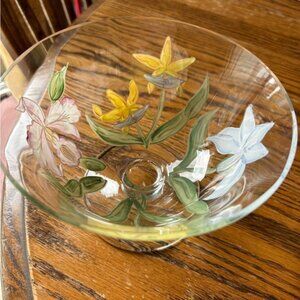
[167,150,210,182]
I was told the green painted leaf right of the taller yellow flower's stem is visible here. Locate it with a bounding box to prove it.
[151,77,209,144]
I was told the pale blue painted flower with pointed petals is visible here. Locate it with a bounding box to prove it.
[203,105,274,200]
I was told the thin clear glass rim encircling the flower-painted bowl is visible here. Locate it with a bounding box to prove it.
[0,16,298,241]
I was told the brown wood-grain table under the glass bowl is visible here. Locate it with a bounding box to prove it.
[2,0,300,300]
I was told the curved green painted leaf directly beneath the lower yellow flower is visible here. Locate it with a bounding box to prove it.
[86,116,143,146]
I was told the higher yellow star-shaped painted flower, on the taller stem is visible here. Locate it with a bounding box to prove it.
[133,36,196,93]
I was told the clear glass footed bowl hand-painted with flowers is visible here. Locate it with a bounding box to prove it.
[1,17,297,251]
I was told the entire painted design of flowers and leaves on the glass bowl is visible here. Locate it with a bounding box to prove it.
[20,36,274,224]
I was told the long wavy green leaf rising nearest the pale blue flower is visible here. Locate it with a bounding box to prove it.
[174,111,216,172]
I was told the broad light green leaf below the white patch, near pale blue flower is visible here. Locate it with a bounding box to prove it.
[169,175,209,214]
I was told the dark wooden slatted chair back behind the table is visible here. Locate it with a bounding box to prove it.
[1,0,93,58]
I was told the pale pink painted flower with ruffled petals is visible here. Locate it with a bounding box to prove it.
[19,98,80,176]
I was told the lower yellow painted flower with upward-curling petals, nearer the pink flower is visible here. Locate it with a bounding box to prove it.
[93,80,142,123]
